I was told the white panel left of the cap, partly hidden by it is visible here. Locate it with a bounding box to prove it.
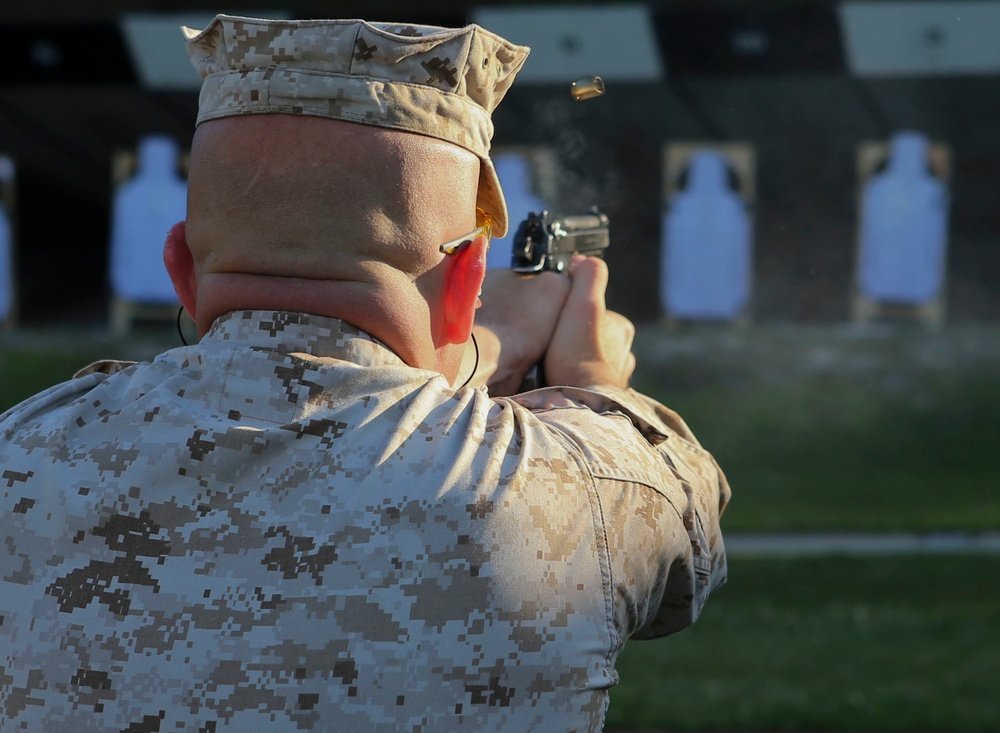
[121,11,289,91]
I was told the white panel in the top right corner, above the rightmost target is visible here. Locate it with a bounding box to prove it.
[839,1,1000,76]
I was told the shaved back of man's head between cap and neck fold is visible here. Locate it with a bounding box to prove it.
[187,114,480,281]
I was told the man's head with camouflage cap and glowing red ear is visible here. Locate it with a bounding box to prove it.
[170,16,527,378]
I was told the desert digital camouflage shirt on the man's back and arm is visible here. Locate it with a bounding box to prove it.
[0,312,729,733]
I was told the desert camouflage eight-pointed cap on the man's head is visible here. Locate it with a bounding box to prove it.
[182,15,529,236]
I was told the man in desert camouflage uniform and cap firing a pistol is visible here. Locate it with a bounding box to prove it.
[0,16,729,731]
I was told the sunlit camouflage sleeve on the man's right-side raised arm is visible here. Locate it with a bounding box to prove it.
[516,387,731,639]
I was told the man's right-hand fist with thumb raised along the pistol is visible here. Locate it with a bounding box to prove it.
[545,257,635,389]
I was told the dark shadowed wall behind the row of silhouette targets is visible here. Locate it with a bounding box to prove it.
[0,0,1000,323]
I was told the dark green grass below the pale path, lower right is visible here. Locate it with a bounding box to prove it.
[607,555,1000,733]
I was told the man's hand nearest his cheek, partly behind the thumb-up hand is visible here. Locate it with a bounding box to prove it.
[469,270,570,396]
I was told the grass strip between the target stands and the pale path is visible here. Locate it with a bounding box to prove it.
[636,330,1000,532]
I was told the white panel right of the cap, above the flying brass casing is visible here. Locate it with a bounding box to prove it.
[472,5,663,84]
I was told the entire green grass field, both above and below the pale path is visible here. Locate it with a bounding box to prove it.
[0,324,1000,733]
